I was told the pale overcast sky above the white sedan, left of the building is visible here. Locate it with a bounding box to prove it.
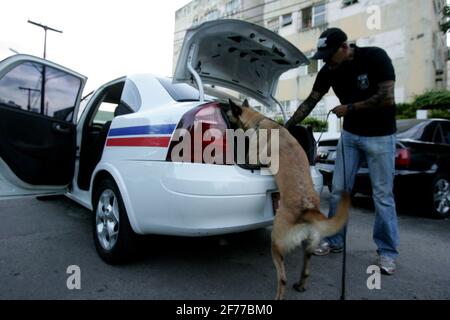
[0,0,190,93]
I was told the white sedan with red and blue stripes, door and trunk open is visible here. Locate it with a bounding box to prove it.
[0,20,322,263]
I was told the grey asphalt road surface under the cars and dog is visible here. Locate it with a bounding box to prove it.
[0,191,450,300]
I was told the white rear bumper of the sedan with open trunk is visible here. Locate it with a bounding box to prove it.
[114,161,277,236]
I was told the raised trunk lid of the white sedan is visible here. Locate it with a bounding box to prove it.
[174,20,308,105]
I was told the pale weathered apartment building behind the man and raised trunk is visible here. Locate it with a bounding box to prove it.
[174,0,448,132]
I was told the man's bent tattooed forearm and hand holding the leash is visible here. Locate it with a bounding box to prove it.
[333,81,395,117]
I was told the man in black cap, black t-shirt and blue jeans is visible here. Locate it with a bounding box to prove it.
[286,28,398,275]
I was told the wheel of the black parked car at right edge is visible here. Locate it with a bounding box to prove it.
[431,174,450,218]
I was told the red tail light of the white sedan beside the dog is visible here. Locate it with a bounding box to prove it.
[166,102,234,164]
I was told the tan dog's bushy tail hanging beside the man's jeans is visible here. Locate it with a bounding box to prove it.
[304,192,350,237]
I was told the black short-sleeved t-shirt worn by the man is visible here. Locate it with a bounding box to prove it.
[313,46,396,136]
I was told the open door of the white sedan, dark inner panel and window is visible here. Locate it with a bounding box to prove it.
[0,55,87,199]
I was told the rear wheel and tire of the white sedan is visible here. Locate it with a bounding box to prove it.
[93,178,138,264]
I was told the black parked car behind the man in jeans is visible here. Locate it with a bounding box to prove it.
[317,119,450,218]
